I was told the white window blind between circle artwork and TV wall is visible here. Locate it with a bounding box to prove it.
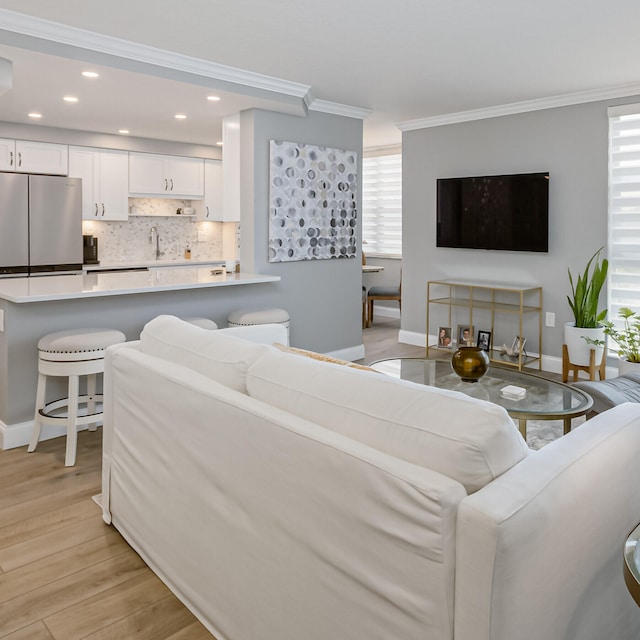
[362,153,402,257]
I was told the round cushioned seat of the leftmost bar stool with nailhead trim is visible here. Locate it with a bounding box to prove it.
[38,329,126,362]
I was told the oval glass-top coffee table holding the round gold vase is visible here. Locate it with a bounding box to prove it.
[369,358,593,440]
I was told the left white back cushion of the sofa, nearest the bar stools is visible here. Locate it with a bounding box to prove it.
[140,315,269,393]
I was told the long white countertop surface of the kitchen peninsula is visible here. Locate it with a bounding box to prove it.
[0,266,280,303]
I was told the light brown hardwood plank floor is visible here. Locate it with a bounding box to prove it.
[0,318,410,640]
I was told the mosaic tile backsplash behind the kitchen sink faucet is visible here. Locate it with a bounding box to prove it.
[82,198,235,263]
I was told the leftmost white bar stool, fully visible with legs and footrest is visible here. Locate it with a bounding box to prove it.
[27,329,126,467]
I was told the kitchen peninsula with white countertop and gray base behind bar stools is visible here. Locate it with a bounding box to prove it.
[0,266,284,444]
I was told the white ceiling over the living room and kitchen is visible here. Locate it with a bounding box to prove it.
[0,0,640,146]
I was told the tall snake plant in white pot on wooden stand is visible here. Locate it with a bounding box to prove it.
[564,247,609,366]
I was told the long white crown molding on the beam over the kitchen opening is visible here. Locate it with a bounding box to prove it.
[0,9,310,100]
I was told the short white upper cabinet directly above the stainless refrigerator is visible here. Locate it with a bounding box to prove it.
[0,139,69,176]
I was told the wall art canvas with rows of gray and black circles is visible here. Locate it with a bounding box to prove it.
[269,140,358,262]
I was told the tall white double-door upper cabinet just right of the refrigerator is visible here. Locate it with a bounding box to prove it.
[69,147,129,220]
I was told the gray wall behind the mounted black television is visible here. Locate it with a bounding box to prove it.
[402,96,640,358]
